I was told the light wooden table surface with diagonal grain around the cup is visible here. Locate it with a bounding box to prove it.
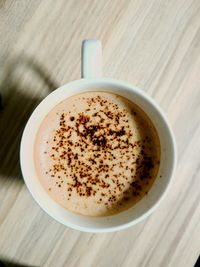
[0,0,200,267]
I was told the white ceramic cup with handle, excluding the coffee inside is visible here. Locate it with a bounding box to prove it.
[20,40,176,233]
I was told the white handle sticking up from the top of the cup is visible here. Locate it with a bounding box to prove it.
[81,40,102,79]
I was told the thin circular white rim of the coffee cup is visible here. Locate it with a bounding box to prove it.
[20,78,177,233]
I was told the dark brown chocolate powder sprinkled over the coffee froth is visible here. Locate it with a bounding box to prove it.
[39,95,161,217]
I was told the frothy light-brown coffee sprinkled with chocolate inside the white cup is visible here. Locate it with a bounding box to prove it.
[34,91,160,216]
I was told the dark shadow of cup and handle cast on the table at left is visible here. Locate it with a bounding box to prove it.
[0,56,57,182]
